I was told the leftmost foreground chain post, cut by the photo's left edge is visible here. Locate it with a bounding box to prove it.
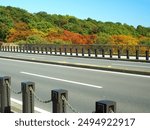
[0,76,11,113]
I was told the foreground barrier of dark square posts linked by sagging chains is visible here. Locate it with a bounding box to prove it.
[0,76,116,113]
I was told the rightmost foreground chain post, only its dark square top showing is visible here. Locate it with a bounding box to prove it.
[95,100,116,113]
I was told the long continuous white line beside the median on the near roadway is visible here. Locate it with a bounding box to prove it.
[0,58,150,78]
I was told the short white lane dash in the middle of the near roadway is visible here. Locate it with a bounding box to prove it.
[20,72,103,88]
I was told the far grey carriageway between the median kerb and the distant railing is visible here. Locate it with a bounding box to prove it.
[0,52,150,73]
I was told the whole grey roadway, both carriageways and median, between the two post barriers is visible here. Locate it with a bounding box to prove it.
[0,44,150,113]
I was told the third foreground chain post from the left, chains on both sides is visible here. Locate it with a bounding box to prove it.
[51,89,68,113]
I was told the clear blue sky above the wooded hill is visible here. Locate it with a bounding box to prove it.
[0,0,150,27]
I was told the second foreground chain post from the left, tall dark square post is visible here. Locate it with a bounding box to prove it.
[21,81,35,113]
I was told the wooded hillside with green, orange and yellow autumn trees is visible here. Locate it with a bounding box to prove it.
[0,6,150,45]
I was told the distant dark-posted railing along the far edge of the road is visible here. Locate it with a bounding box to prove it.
[0,44,150,61]
